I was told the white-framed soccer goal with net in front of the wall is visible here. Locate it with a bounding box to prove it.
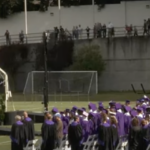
[23,71,98,100]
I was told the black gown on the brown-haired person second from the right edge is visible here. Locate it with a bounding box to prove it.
[129,126,144,150]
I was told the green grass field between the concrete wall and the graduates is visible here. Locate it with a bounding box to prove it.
[0,92,150,150]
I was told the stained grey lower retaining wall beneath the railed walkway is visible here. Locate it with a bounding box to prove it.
[12,37,150,92]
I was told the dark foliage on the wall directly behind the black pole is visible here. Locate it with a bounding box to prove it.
[36,40,74,71]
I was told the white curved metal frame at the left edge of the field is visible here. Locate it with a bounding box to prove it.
[0,68,12,111]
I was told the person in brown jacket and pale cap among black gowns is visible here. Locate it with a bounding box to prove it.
[55,113,63,148]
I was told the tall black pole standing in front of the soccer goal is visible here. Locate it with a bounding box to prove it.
[43,33,48,111]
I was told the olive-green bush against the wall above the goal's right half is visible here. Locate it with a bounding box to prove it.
[69,44,105,75]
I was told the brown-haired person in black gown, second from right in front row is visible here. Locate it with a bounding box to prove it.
[128,117,144,150]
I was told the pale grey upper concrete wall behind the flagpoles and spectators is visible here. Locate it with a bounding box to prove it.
[0,1,150,35]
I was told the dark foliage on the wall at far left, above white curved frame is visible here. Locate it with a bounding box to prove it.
[0,44,28,88]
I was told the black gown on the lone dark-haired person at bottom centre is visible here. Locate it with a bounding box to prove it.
[68,122,82,150]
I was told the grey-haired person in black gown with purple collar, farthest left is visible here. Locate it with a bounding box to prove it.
[10,116,28,150]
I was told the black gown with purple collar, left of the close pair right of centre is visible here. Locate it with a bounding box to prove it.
[98,123,113,150]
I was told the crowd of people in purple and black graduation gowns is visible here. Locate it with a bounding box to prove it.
[11,96,150,150]
